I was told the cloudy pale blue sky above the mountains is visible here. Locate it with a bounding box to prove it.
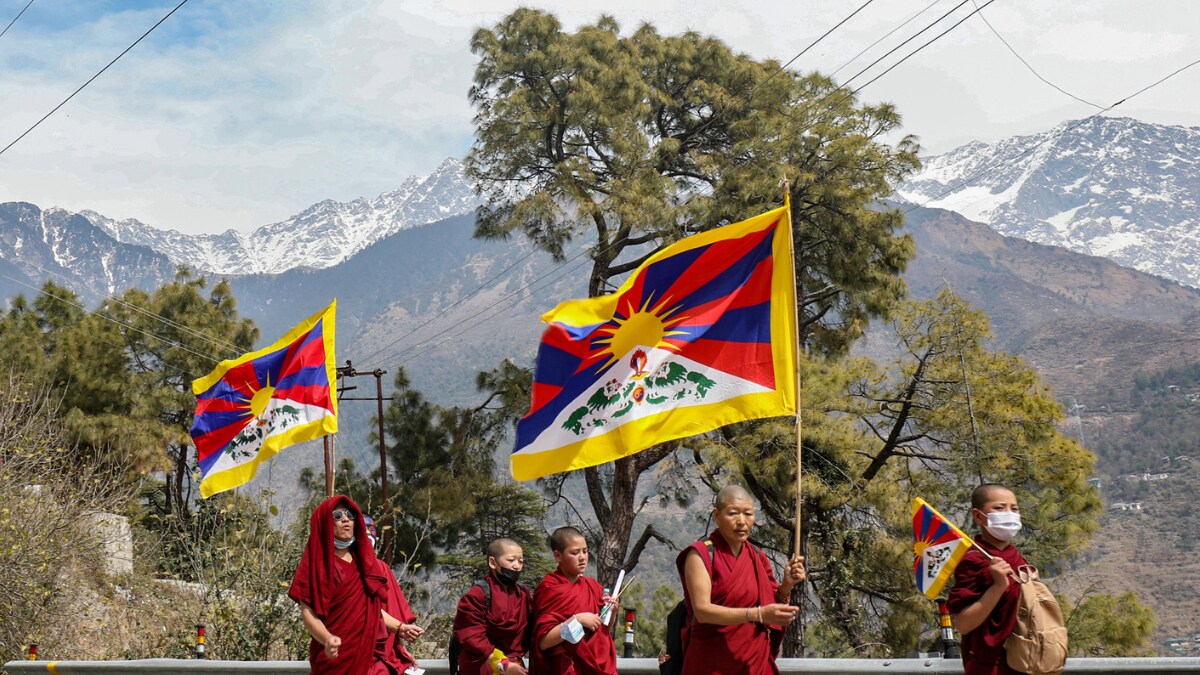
[0,0,1200,233]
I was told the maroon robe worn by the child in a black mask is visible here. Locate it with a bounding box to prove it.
[454,574,533,675]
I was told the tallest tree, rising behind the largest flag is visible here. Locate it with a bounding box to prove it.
[467,8,918,583]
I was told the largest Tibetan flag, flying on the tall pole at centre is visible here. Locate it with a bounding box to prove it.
[511,207,796,480]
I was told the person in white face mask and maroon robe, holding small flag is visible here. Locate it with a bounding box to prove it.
[947,483,1028,675]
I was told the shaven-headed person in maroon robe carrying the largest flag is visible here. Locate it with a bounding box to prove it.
[676,485,805,675]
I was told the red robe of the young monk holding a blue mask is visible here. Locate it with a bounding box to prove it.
[530,571,617,675]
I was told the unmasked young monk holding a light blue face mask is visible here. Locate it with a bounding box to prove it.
[530,527,617,675]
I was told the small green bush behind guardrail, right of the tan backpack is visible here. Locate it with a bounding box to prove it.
[1058,592,1154,656]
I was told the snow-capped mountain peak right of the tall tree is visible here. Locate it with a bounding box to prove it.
[896,117,1200,287]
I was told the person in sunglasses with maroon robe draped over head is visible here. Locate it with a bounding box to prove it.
[288,495,402,675]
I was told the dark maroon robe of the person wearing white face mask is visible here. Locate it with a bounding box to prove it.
[946,539,1028,675]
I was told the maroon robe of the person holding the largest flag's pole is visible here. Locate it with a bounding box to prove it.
[676,532,784,675]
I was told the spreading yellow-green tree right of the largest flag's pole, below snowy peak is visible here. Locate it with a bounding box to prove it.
[702,291,1102,657]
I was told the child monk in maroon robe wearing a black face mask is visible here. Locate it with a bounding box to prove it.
[454,537,533,675]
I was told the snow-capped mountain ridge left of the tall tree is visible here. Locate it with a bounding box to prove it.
[79,159,480,275]
